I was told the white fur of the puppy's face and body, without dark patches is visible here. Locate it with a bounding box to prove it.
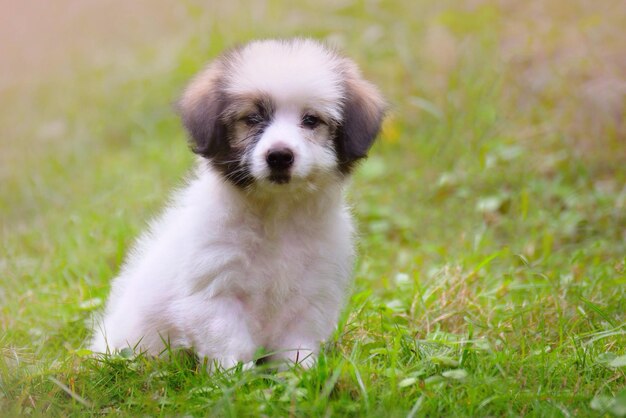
[91,37,372,367]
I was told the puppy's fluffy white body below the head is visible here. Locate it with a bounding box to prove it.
[92,163,353,367]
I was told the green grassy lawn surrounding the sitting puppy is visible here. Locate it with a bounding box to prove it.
[0,1,626,416]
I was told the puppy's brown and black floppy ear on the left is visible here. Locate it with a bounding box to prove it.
[177,63,228,158]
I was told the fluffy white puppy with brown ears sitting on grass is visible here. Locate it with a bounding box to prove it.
[91,39,385,368]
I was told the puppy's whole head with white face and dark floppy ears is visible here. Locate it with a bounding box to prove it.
[179,39,384,187]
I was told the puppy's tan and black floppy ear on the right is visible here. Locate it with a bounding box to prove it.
[336,65,387,174]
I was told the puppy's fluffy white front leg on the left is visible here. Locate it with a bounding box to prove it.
[182,296,257,371]
